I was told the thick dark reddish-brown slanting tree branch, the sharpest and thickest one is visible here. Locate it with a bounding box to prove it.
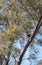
[17,15,42,65]
